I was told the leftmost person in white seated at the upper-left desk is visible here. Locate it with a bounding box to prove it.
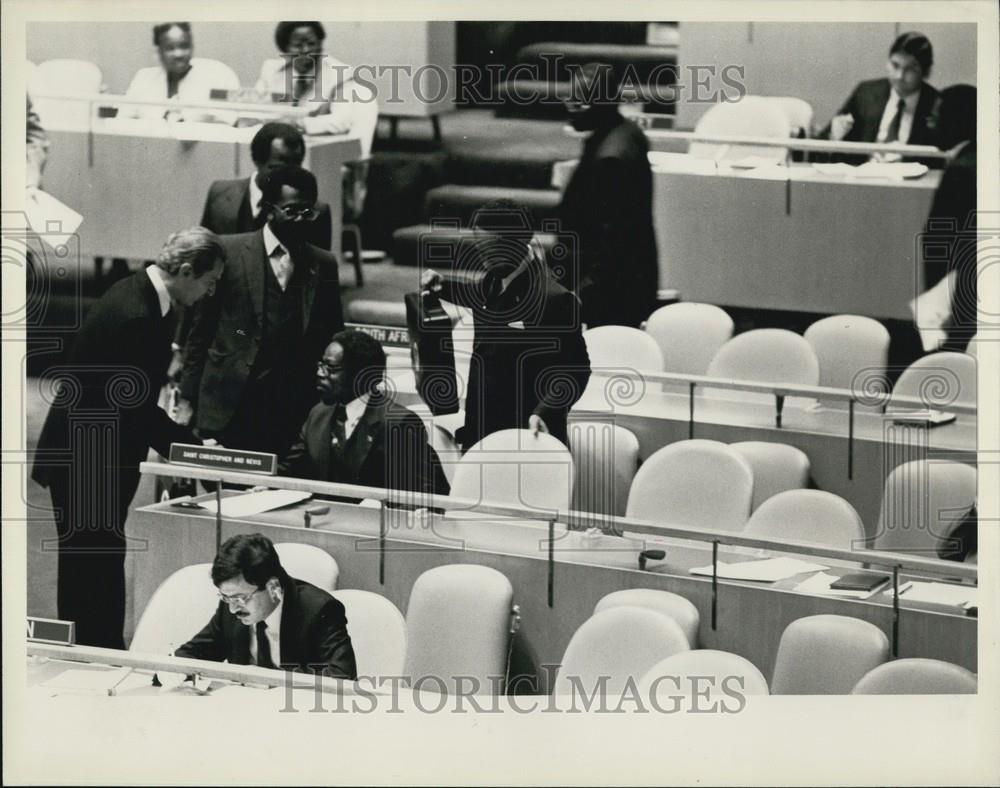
[118,22,240,123]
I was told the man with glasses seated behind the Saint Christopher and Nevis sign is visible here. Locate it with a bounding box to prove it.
[279,331,448,495]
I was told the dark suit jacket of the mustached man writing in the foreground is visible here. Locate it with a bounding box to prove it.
[174,577,358,679]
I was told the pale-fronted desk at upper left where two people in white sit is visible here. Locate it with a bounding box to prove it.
[42,118,361,266]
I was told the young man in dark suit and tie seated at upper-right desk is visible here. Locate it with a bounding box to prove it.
[818,33,940,166]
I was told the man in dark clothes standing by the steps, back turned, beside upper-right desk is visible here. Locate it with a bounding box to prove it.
[559,64,659,328]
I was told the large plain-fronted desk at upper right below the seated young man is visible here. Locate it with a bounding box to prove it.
[653,154,941,320]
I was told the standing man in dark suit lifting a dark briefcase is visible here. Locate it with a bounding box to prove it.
[421,200,590,451]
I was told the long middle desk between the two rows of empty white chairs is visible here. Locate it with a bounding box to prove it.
[378,362,977,537]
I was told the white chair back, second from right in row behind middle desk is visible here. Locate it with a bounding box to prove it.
[803,315,889,400]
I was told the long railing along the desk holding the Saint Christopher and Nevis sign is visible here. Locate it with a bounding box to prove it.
[140,454,978,580]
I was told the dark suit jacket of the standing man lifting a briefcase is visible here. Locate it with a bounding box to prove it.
[441,264,590,450]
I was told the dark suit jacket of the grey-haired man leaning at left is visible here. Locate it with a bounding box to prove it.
[32,271,200,507]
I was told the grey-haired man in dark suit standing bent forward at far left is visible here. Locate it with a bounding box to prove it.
[32,227,225,648]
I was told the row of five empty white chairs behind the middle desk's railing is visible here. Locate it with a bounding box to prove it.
[584,302,976,407]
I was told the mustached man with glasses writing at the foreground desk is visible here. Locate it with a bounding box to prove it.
[174,534,358,680]
